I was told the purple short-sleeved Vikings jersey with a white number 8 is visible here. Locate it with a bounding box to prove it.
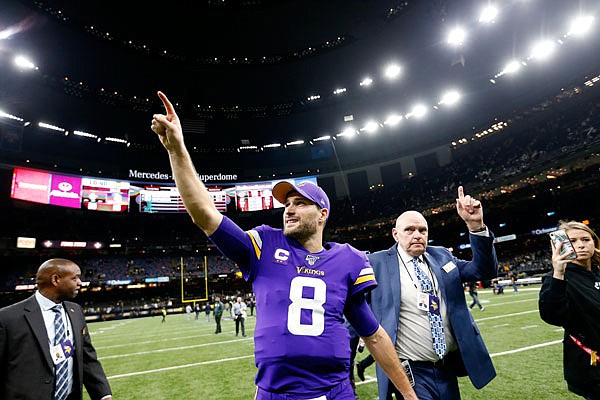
[211,218,377,396]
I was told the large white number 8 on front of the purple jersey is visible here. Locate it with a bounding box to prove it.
[288,276,327,336]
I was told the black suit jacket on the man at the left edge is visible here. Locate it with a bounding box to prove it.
[0,296,111,400]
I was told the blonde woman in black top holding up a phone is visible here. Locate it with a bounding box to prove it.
[539,221,600,399]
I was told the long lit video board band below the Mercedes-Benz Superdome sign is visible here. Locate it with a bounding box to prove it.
[10,168,317,213]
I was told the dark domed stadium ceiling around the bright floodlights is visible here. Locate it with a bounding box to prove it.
[0,0,600,153]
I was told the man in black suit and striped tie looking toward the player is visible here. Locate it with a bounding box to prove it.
[0,258,112,400]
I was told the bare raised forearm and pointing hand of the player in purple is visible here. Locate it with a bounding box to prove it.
[151,92,223,236]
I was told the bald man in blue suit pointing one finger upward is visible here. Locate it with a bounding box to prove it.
[367,186,498,400]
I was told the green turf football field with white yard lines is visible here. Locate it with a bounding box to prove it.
[84,286,580,400]
